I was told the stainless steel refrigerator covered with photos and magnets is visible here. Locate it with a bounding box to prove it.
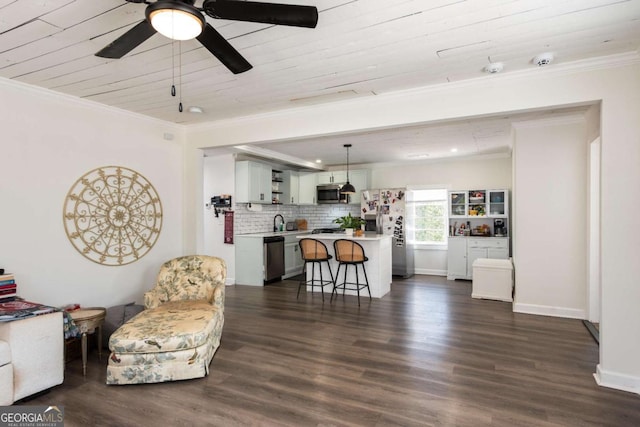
[360,188,414,278]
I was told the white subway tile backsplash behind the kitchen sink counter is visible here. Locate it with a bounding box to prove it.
[234,203,360,234]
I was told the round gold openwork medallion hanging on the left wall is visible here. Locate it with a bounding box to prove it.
[63,166,162,265]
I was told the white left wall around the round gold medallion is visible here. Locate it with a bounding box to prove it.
[0,79,184,307]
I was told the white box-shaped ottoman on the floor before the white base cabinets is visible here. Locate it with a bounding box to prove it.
[471,258,513,302]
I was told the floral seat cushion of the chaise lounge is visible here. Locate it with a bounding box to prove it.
[109,300,222,353]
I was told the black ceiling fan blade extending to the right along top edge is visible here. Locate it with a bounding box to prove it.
[202,0,318,28]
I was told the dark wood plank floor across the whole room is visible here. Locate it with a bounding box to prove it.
[27,276,640,427]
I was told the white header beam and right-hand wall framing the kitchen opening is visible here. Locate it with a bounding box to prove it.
[185,59,640,392]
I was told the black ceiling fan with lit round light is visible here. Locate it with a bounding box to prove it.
[96,0,318,74]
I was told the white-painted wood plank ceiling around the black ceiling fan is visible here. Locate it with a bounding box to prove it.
[0,0,640,164]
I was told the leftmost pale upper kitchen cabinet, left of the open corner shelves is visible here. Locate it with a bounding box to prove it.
[235,160,272,204]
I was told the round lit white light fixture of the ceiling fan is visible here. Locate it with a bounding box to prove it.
[145,1,205,40]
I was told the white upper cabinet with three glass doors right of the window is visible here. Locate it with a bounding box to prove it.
[449,190,509,218]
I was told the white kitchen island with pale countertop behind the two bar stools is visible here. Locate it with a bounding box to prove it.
[296,233,391,298]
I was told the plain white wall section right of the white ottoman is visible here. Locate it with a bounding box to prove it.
[512,116,589,319]
